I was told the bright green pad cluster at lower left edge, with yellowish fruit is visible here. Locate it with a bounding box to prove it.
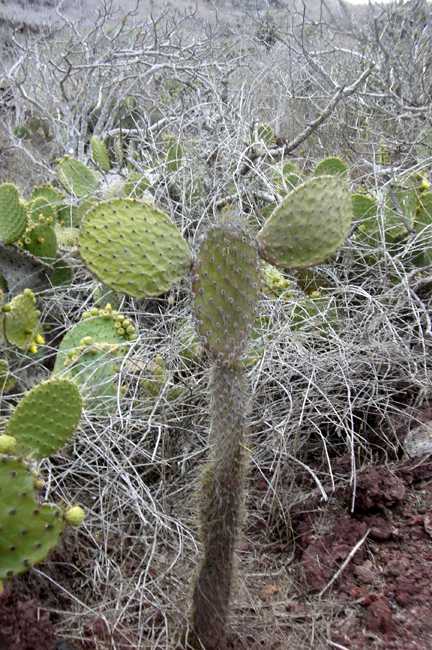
[0,379,84,580]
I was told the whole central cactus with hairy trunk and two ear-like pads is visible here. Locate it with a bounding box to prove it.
[78,176,352,650]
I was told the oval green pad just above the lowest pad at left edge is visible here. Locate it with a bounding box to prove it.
[4,379,82,457]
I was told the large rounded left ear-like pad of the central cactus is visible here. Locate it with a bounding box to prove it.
[78,199,192,298]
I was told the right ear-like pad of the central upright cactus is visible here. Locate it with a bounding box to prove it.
[257,176,352,268]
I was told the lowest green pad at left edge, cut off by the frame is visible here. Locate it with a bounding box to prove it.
[0,456,65,580]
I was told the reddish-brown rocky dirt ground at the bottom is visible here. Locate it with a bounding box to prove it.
[0,442,432,650]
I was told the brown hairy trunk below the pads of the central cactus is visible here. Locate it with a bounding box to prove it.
[192,364,246,650]
